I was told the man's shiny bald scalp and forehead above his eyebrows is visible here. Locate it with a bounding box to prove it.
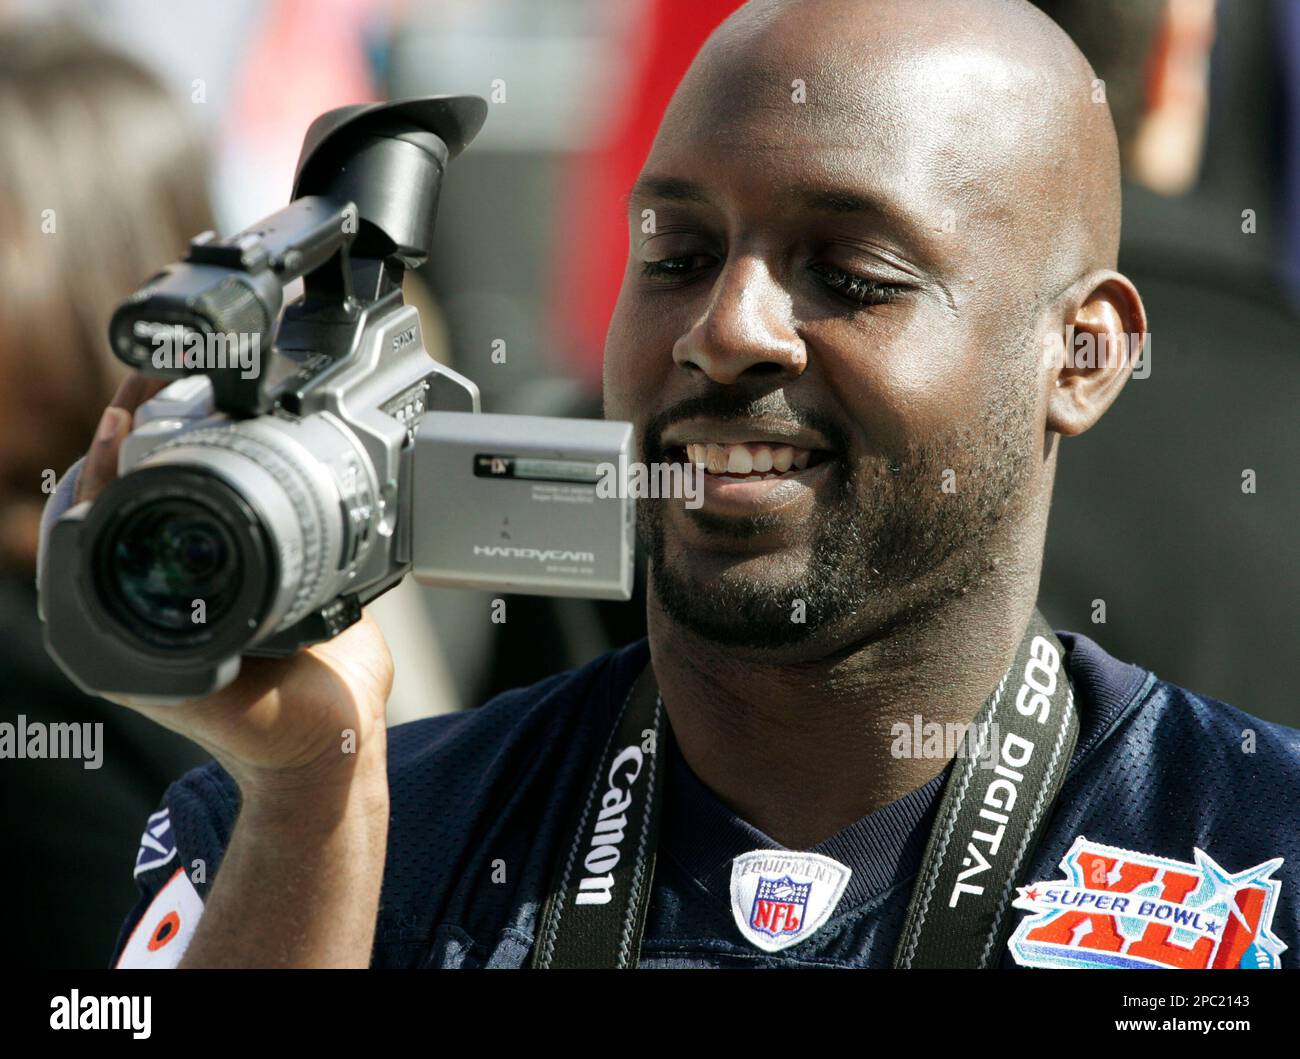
[633,0,1118,275]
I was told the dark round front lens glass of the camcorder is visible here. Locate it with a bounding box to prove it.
[100,498,242,646]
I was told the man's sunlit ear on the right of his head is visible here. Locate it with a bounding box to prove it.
[1047,278,1147,437]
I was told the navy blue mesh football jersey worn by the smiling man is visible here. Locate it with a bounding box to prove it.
[114,633,1300,968]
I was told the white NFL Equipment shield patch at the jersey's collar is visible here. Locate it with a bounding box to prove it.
[731,850,853,952]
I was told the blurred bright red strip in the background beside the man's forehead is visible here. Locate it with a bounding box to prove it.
[551,0,742,391]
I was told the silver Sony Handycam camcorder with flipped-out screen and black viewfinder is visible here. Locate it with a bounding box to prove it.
[39,96,634,702]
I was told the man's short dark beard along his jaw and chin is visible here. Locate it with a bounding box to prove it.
[637,373,1036,648]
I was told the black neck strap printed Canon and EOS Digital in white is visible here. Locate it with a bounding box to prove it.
[533,611,1079,968]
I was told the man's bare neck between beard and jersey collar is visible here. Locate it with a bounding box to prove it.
[649,569,1037,850]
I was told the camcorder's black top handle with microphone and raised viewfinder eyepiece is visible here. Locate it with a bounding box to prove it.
[109,96,488,418]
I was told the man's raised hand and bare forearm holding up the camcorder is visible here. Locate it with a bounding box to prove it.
[73,374,393,967]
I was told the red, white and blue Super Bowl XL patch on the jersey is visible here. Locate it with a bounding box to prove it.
[1008,836,1287,969]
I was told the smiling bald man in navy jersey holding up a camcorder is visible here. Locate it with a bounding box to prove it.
[78,0,1300,968]
